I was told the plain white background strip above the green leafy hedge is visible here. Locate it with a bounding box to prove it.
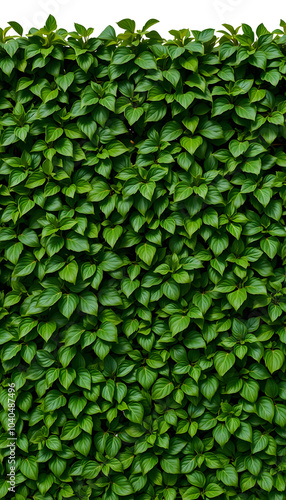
[0,0,286,39]
